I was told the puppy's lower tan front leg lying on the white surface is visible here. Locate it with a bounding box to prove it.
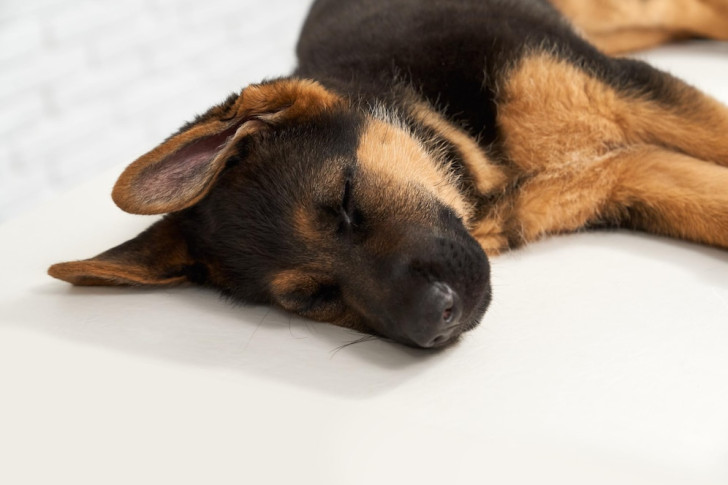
[472,145,728,251]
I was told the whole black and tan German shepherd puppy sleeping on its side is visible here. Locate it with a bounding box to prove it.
[49,0,728,348]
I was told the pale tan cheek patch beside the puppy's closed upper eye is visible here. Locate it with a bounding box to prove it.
[357,119,472,226]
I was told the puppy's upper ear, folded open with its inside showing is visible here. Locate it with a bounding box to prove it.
[112,79,341,214]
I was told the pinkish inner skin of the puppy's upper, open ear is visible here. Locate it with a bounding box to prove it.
[133,125,238,206]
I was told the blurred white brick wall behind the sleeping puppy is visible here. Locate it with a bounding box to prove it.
[0,0,310,222]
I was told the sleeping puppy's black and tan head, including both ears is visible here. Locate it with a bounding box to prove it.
[49,79,490,347]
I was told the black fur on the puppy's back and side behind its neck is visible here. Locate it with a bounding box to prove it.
[297,0,580,141]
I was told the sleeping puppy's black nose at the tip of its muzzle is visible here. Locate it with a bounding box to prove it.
[405,281,462,348]
